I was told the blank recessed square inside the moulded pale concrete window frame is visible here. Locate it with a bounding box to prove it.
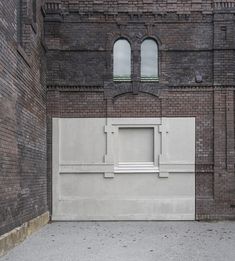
[118,128,154,162]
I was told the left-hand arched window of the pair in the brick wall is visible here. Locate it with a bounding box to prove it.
[113,39,131,81]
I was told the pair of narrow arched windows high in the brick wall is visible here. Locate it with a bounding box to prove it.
[113,39,159,81]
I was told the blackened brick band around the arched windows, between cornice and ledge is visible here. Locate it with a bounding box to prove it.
[45,20,213,85]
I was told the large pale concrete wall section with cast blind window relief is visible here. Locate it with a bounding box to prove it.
[52,117,195,221]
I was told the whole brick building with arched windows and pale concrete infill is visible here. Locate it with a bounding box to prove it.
[0,0,235,250]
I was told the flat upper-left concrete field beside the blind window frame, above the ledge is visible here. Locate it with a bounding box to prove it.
[60,119,106,164]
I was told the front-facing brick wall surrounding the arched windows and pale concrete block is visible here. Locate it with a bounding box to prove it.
[45,0,235,220]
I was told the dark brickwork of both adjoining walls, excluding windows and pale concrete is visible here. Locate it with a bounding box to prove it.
[0,0,235,234]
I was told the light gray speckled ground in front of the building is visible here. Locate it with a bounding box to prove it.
[0,222,235,261]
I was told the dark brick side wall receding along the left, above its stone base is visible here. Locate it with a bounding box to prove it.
[0,0,48,235]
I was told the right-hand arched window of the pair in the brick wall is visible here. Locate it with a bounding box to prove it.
[141,39,158,81]
